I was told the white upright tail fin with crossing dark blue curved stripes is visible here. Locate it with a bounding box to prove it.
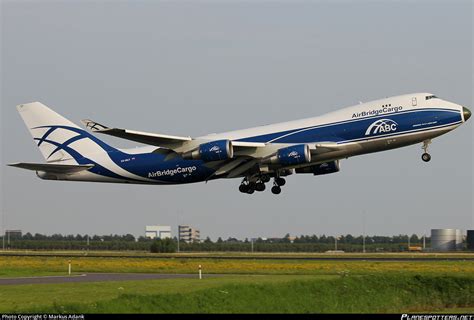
[17,102,116,163]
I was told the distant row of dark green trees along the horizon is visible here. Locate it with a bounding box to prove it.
[0,233,436,252]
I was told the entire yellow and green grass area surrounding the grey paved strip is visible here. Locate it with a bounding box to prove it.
[0,255,474,313]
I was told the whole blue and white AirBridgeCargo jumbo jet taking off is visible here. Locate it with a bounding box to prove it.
[10,93,471,194]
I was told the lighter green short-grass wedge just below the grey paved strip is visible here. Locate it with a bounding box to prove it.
[0,276,334,312]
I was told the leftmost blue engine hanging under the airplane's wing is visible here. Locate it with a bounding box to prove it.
[183,140,234,162]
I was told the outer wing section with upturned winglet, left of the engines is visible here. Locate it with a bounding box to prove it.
[82,120,192,147]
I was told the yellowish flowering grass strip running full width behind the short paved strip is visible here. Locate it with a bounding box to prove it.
[0,256,474,277]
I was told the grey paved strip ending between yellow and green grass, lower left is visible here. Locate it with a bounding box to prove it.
[0,273,209,286]
